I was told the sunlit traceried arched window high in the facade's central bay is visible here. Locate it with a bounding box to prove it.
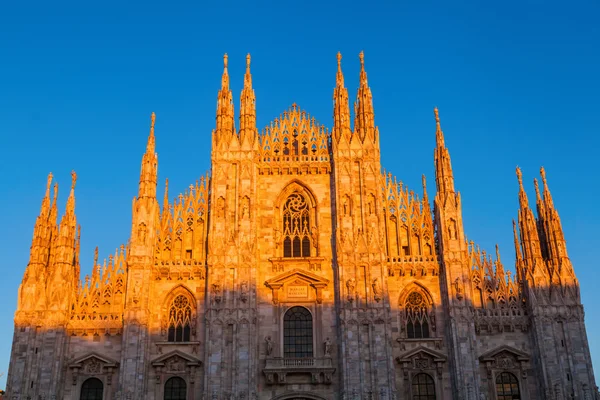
[283,193,310,257]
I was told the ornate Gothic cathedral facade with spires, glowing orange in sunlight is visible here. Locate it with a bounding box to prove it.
[7,53,596,400]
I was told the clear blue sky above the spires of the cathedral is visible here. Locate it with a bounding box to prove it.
[0,0,600,387]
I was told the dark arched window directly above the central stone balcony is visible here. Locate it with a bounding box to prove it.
[283,306,313,358]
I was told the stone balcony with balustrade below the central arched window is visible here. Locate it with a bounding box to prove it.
[263,357,335,385]
